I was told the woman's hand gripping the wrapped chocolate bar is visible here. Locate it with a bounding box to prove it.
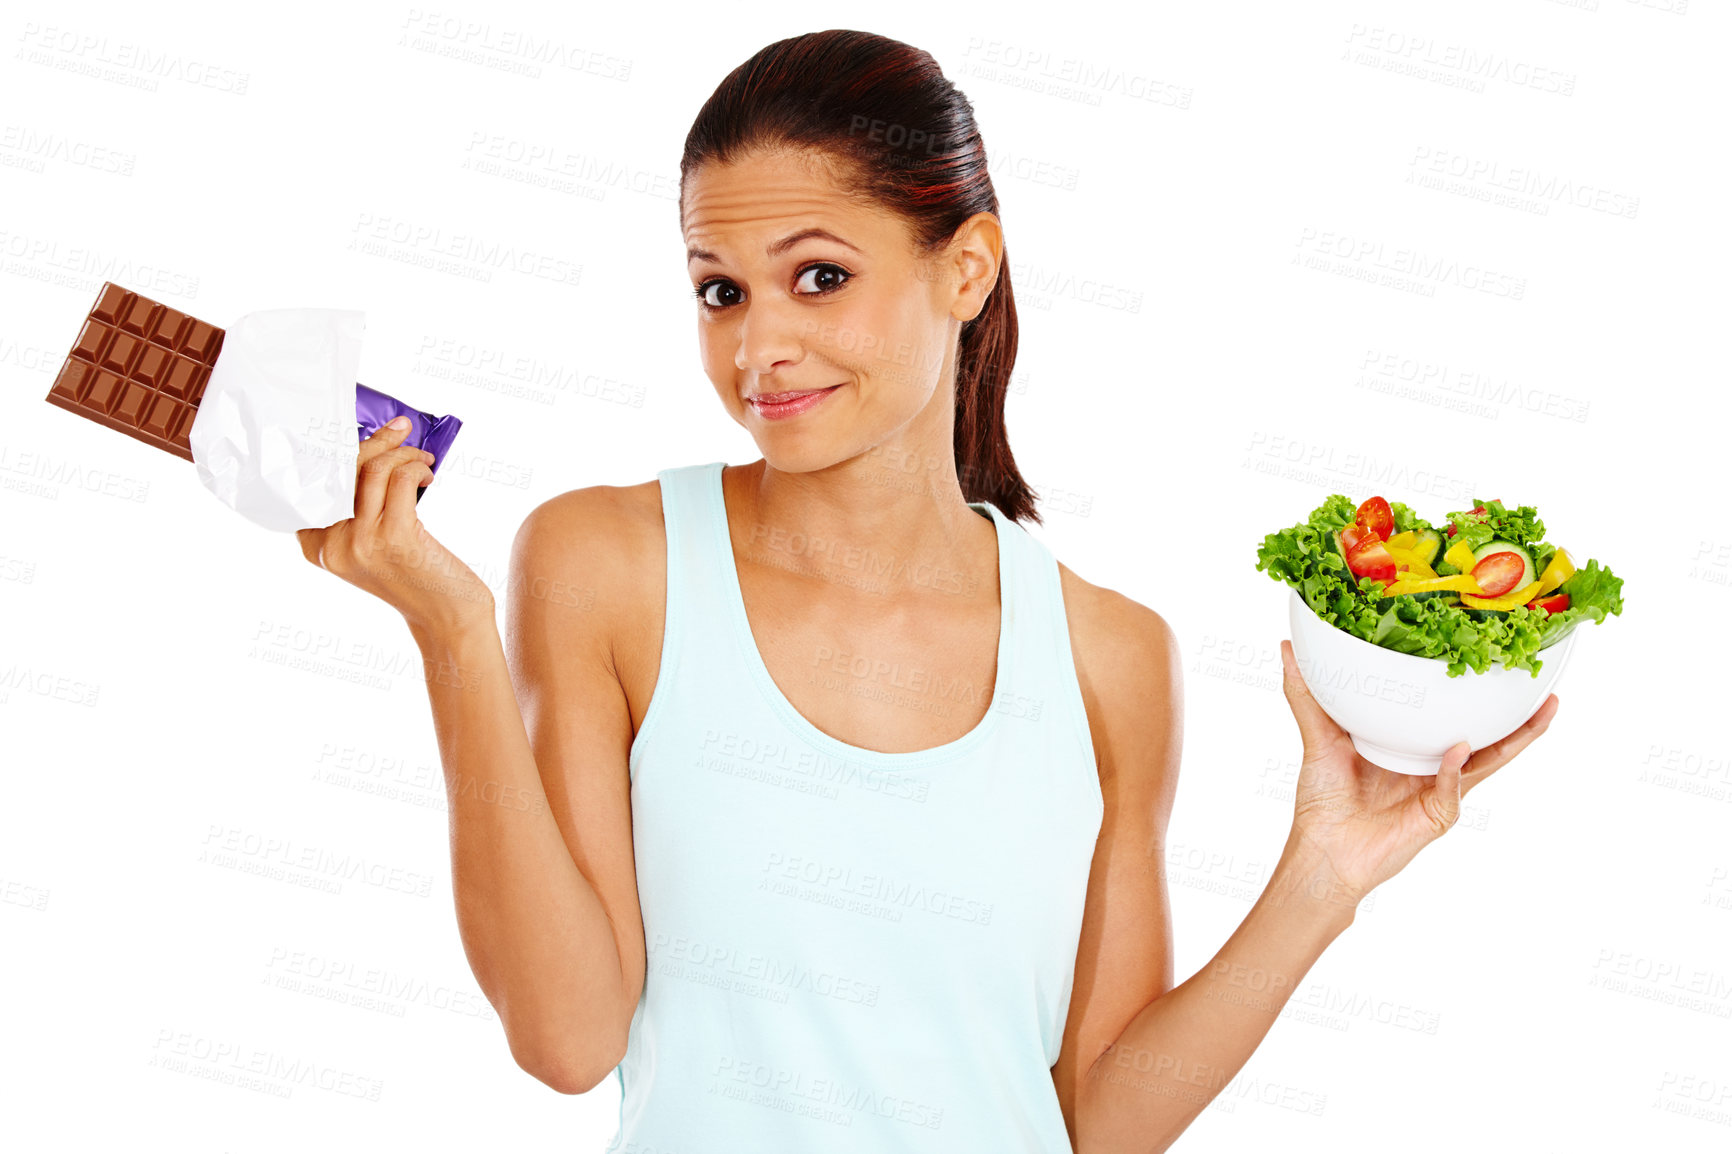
[294,418,494,632]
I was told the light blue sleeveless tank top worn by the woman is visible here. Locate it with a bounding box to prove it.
[608,461,1102,1154]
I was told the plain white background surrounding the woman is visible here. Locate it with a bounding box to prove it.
[0,0,1732,1152]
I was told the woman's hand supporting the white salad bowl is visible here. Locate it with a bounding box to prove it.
[1282,641,1557,904]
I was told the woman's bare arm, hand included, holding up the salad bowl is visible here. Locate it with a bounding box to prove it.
[1053,594,1557,1154]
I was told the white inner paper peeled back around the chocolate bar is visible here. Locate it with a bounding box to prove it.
[187,308,365,532]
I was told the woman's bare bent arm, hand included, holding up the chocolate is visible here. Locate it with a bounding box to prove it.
[300,422,644,1093]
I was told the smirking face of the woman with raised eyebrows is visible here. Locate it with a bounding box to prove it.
[684,151,1003,471]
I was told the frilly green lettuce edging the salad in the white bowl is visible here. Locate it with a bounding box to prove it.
[1257,494,1623,677]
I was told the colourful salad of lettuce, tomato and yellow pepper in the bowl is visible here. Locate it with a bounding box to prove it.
[1257,494,1623,677]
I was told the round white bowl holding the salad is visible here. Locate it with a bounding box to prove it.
[1287,586,1581,775]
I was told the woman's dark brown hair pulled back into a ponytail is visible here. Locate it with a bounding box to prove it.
[679,28,1041,523]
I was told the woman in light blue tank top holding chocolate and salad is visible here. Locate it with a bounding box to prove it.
[300,31,1557,1154]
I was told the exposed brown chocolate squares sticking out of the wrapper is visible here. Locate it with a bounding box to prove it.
[48,282,223,461]
